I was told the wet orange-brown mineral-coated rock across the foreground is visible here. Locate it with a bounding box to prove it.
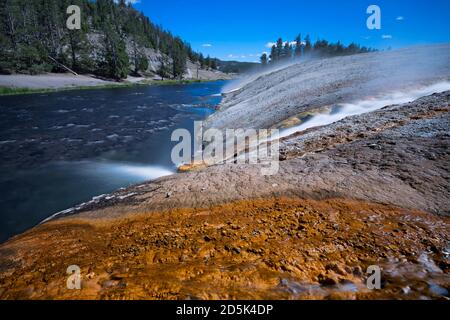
[0,198,450,299]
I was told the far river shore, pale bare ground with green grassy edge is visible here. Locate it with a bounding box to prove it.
[0,73,230,96]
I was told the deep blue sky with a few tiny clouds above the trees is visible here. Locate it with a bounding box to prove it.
[130,0,450,61]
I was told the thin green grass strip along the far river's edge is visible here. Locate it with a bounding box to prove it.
[0,79,225,96]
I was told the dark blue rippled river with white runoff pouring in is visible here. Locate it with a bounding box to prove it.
[0,81,225,242]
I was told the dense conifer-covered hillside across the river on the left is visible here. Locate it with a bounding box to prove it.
[0,0,217,80]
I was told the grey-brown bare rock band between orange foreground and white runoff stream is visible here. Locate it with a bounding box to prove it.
[51,92,450,219]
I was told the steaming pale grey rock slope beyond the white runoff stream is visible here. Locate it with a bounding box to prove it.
[211,44,450,129]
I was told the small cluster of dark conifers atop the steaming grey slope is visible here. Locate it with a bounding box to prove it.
[260,35,375,65]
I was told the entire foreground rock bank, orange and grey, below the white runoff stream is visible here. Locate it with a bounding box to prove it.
[0,91,450,299]
